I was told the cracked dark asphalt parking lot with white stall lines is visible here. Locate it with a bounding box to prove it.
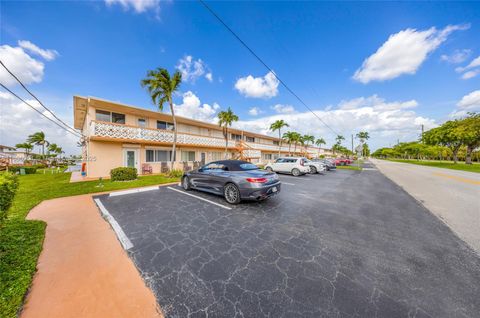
[94,167,480,317]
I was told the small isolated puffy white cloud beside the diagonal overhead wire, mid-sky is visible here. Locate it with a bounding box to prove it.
[235,72,279,98]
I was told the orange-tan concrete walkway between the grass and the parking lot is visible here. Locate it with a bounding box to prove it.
[21,195,162,318]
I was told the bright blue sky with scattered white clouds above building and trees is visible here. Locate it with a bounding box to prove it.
[0,0,480,153]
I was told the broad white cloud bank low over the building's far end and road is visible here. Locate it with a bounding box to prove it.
[234,95,436,148]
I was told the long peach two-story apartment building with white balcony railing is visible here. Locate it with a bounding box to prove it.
[73,96,332,178]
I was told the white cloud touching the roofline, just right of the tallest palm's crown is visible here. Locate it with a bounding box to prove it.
[174,91,220,122]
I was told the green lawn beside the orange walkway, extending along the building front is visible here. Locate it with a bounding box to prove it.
[0,170,178,318]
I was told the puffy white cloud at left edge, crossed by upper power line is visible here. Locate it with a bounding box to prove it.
[0,45,45,86]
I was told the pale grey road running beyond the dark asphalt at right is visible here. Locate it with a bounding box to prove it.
[371,159,480,254]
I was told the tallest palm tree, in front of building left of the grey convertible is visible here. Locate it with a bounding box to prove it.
[140,67,182,170]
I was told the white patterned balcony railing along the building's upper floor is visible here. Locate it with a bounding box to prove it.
[90,120,235,148]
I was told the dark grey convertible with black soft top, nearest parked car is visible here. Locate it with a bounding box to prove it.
[182,160,281,204]
